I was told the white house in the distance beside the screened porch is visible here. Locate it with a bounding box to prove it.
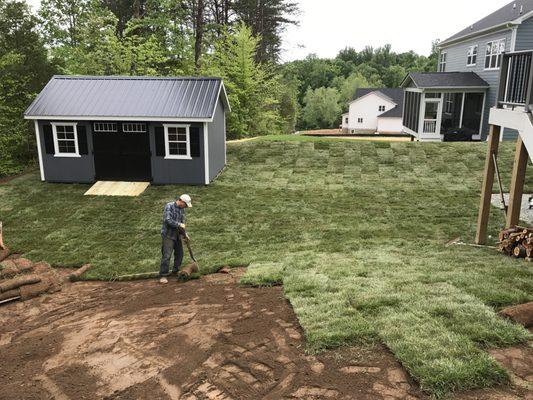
[341,88,404,134]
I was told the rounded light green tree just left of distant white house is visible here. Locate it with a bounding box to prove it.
[302,87,341,129]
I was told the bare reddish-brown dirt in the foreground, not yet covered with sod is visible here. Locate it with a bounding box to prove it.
[0,270,533,400]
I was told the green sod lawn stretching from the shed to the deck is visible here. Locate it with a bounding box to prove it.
[0,137,533,396]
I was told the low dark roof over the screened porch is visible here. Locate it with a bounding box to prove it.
[401,72,489,89]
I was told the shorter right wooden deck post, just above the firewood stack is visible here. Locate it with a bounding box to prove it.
[505,136,528,228]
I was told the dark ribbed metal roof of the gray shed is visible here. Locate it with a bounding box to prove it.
[24,76,229,120]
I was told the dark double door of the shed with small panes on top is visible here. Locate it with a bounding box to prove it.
[93,122,152,182]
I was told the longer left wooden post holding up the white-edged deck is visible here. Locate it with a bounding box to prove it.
[476,125,501,244]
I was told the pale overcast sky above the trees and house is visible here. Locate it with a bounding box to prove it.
[27,0,511,61]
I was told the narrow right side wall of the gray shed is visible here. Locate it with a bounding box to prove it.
[209,99,226,181]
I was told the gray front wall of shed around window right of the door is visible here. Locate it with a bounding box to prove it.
[150,123,205,185]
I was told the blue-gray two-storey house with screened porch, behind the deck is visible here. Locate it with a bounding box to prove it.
[402,0,533,140]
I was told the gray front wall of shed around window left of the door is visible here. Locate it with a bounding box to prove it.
[38,121,94,183]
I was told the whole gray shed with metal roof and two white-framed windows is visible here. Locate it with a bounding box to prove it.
[24,76,231,185]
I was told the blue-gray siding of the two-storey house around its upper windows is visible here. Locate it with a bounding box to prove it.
[441,29,512,140]
